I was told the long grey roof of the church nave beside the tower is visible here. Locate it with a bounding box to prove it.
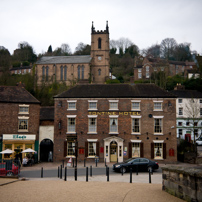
[36,55,91,64]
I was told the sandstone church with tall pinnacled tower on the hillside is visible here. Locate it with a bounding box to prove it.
[36,22,109,86]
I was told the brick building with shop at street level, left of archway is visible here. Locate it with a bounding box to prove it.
[0,86,40,163]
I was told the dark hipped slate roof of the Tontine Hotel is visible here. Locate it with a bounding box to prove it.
[54,84,176,98]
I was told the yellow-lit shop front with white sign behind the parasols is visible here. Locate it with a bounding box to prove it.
[2,134,38,162]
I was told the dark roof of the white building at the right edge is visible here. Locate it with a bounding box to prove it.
[170,90,202,98]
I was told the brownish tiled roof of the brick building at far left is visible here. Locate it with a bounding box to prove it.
[0,86,40,104]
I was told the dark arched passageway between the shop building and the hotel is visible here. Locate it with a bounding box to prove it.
[40,139,53,162]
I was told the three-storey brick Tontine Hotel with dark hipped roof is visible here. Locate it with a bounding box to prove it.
[54,84,177,162]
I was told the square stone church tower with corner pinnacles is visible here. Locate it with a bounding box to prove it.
[91,21,109,84]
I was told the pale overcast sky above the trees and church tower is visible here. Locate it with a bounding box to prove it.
[0,0,202,54]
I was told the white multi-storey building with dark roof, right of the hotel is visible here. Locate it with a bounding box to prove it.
[171,84,202,142]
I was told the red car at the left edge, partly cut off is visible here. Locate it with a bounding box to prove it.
[0,162,20,176]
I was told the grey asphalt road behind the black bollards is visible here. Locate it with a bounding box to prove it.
[20,168,162,178]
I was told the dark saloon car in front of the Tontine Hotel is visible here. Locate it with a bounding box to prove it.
[113,158,159,173]
